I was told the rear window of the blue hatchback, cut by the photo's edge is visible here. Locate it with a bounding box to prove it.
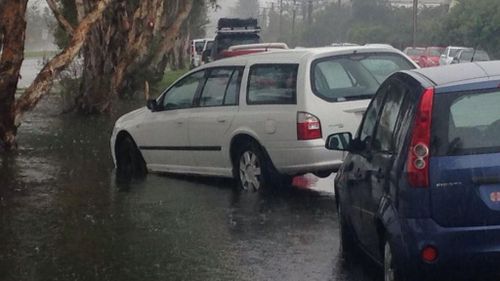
[432,90,500,156]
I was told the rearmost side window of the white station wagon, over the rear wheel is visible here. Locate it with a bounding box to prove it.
[247,64,299,105]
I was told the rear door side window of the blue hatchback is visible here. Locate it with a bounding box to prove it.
[372,81,409,152]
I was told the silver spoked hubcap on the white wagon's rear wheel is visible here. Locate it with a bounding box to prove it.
[240,151,262,190]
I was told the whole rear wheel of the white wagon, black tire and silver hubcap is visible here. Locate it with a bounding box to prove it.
[234,142,293,191]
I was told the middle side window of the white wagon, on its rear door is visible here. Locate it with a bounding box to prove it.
[200,68,234,107]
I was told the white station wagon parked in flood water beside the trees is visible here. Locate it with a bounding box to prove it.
[111,47,418,190]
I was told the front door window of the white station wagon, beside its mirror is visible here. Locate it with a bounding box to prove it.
[162,71,205,110]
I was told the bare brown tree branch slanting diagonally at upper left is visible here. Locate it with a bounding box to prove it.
[15,0,111,126]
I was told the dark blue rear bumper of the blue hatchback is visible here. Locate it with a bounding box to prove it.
[393,219,500,280]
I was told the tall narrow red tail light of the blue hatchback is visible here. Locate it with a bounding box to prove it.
[407,88,434,188]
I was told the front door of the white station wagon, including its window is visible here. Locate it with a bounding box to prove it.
[137,71,205,172]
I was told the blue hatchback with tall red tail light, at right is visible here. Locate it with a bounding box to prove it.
[326,61,500,281]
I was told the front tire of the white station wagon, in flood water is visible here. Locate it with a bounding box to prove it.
[116,137,147,180]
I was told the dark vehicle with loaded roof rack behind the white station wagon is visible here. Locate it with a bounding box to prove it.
[211,18,261,61]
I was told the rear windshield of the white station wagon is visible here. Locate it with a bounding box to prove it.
[311,53,415,102]
